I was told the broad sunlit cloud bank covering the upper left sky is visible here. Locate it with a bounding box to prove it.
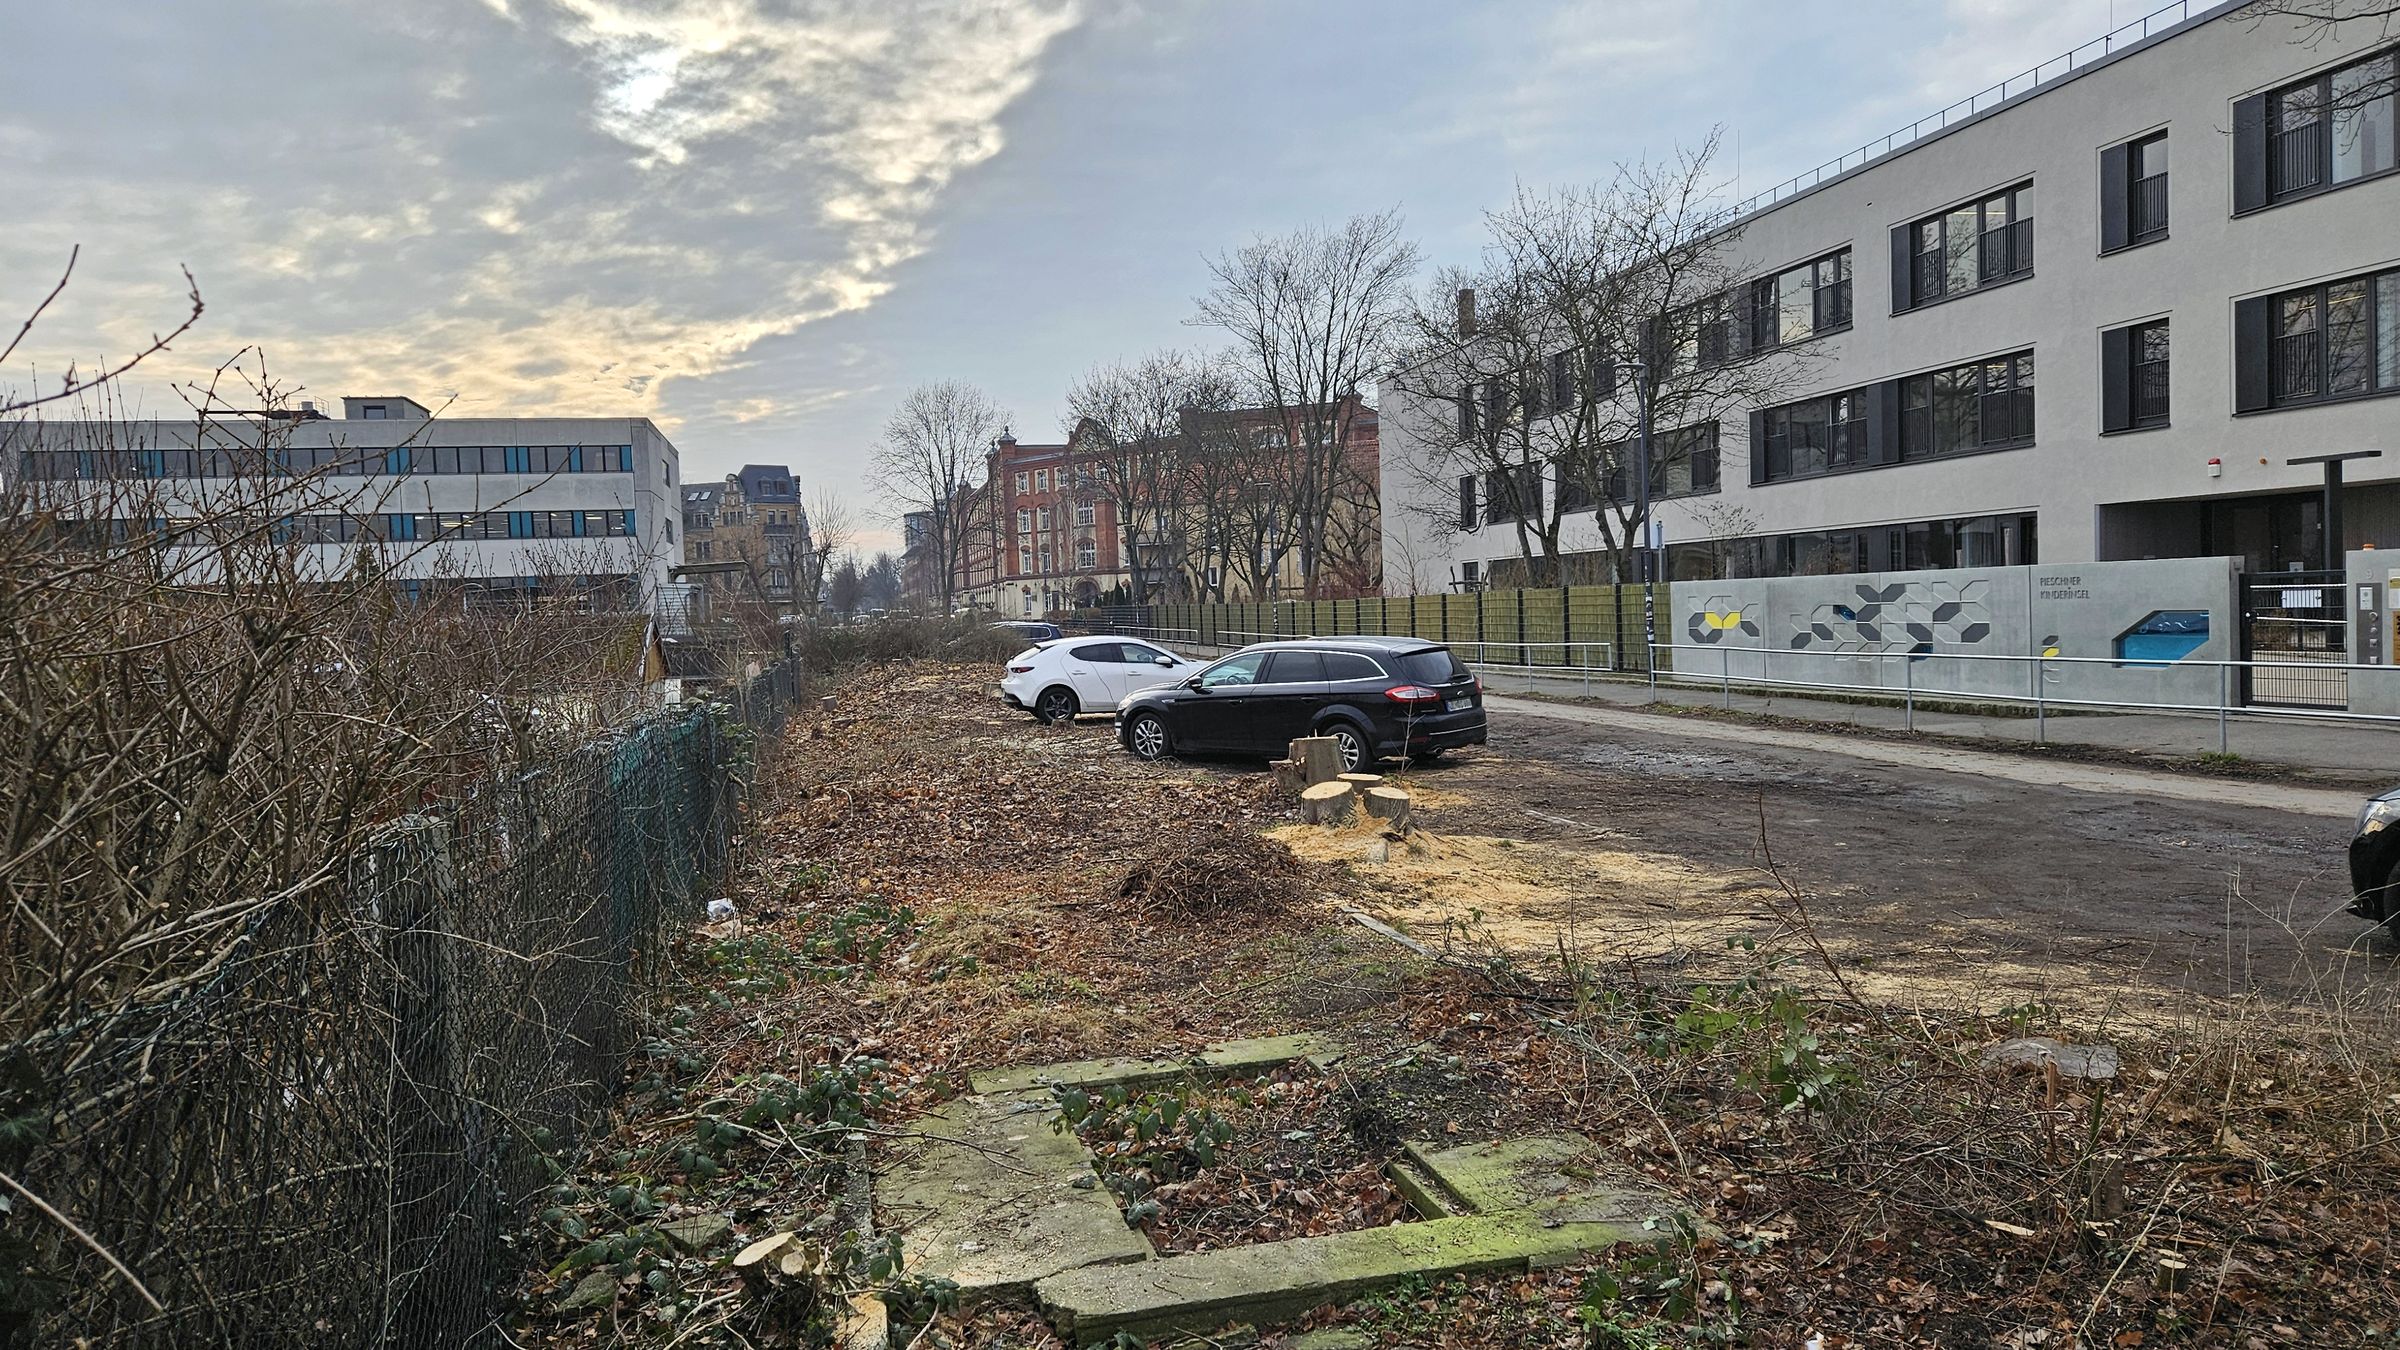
[0,0,1082,420]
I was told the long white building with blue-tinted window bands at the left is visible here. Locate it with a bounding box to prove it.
[14,396,682,605]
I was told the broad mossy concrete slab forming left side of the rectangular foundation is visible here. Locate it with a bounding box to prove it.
[876,1080,1152,1295]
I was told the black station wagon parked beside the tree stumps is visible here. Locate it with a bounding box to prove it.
[1116,637,1486,771]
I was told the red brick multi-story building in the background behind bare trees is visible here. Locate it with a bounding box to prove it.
[955,401,1380,615]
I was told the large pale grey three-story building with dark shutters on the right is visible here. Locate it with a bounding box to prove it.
[1382,0,2400,589]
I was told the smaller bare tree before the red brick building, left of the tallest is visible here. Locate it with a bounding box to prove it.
[1066,351,1236,605]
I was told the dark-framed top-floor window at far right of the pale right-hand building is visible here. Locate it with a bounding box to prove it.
[2234,50,2400,214]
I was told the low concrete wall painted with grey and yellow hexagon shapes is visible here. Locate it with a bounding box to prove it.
[1661,555,2236,706]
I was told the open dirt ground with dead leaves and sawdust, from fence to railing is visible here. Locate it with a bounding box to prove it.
[516,668,2400,1350]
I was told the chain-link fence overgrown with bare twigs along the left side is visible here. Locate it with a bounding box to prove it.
[18,663,802,1348]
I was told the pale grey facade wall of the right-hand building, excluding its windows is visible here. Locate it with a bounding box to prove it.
[1382,5,2400,583]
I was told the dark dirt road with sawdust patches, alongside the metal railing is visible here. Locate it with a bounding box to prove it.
[1363,701,2400,1006]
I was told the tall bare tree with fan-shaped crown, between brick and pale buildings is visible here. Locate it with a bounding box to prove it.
[1195,211,1418,596]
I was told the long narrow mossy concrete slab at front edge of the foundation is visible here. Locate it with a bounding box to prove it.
[1034,1213,1649,1345]
